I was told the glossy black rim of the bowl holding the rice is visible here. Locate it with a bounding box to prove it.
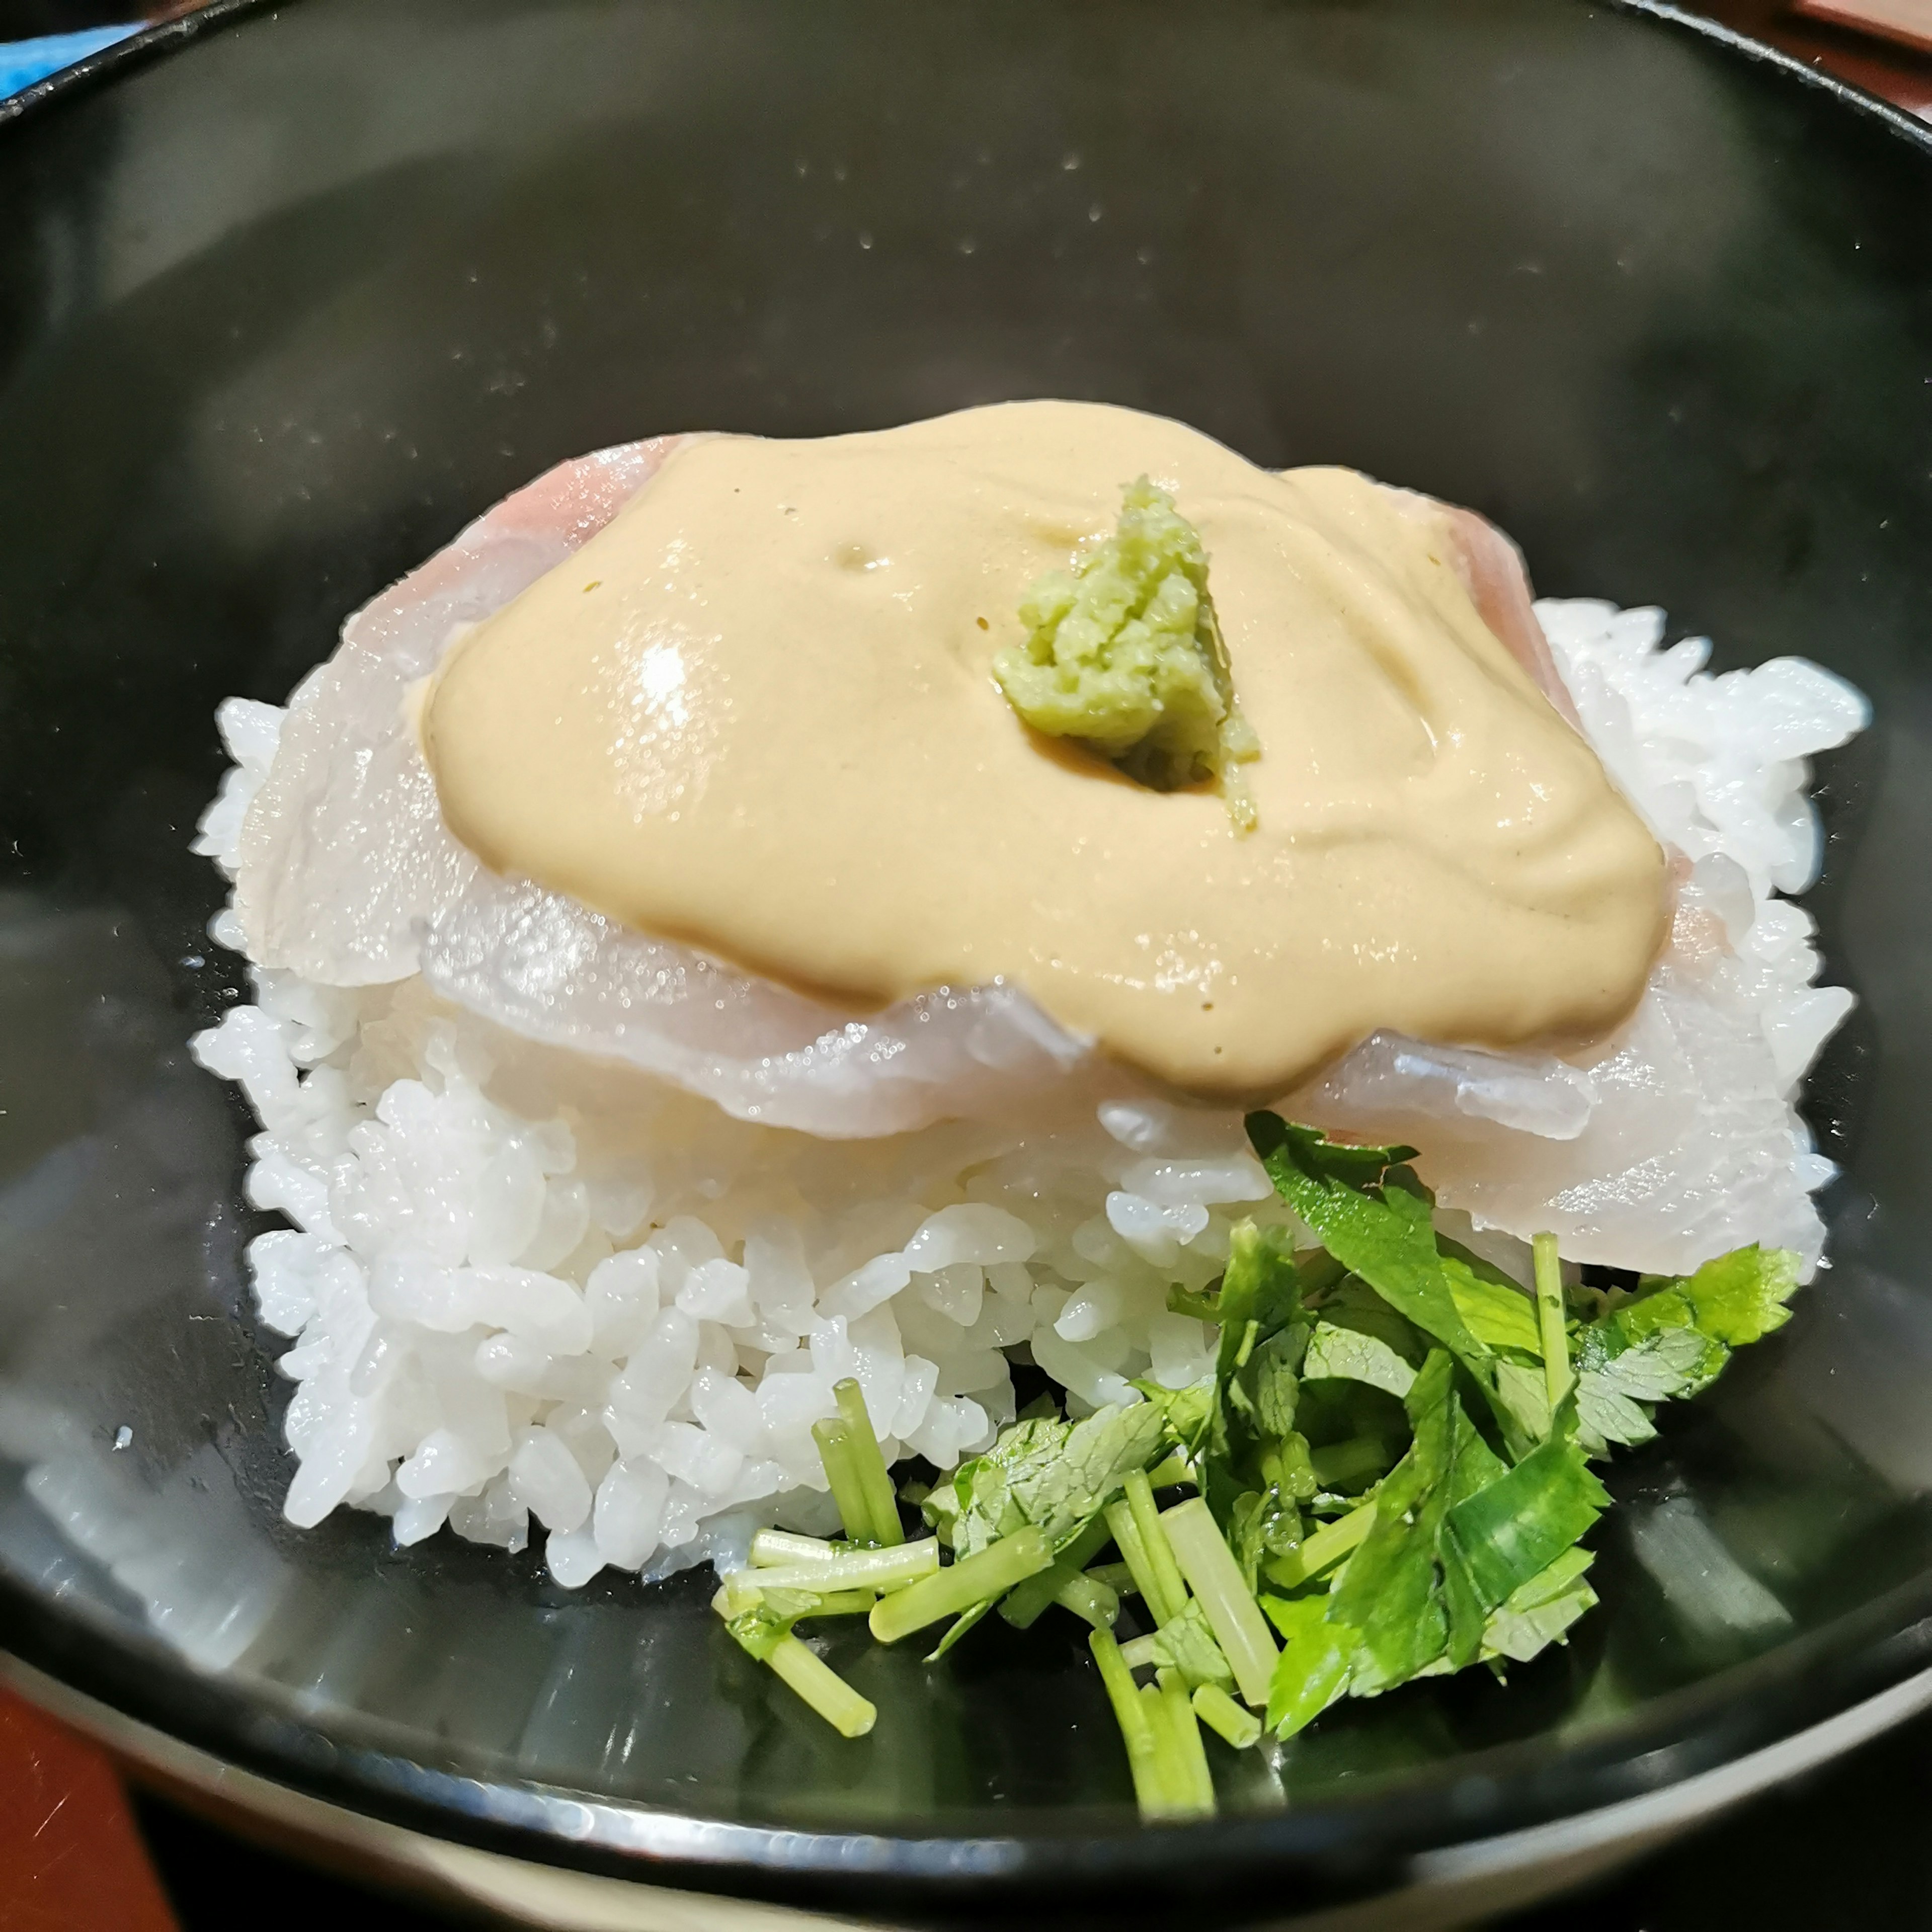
[0,0,1932,1916]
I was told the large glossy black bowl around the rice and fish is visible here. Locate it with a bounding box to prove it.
[0,0,1932,1922]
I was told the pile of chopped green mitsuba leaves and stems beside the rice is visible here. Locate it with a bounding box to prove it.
[715,1113,1799,1818]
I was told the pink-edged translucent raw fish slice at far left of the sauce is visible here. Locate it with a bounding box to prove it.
[235,439,676,985]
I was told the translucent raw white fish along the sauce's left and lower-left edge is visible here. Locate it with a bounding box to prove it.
[229,439,1136,1138]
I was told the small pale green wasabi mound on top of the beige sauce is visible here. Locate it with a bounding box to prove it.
[993,477,1262,831]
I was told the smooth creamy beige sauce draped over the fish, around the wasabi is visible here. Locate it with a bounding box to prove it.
[423,402,1667,1099]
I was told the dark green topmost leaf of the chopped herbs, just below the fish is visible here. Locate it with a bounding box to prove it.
[1223,1113,1490,1362]
